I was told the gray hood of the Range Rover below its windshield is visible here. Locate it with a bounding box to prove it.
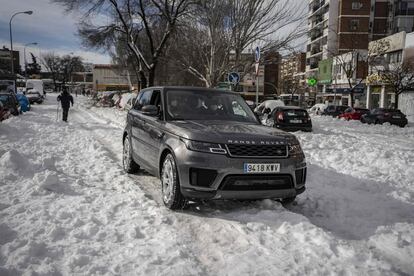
[170,121,297,145]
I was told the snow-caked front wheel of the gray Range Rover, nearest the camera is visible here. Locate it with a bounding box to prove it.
[161,153,187,210]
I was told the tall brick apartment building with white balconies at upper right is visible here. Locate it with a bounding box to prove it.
[306,0,414,77]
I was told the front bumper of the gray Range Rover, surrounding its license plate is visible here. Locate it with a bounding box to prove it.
[175,145,306,199]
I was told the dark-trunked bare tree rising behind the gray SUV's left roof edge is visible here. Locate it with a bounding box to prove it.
[53,0,193,87]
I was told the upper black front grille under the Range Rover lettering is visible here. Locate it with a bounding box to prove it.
[226,144,288,157]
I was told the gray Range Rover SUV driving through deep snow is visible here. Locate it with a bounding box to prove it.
[123,87,306,209]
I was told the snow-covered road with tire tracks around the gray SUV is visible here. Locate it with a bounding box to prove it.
[0,95,414,275]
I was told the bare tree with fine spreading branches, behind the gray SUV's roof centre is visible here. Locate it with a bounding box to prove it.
[173,0,304,87]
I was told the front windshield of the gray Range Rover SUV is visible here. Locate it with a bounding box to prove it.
[166,90,258,123]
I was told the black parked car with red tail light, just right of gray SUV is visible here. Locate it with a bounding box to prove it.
[265,106,312,131]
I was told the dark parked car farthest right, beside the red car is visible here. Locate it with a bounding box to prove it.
[361,108,408,127]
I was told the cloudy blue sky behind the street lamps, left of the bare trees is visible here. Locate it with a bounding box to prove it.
[0,0,111,64]
